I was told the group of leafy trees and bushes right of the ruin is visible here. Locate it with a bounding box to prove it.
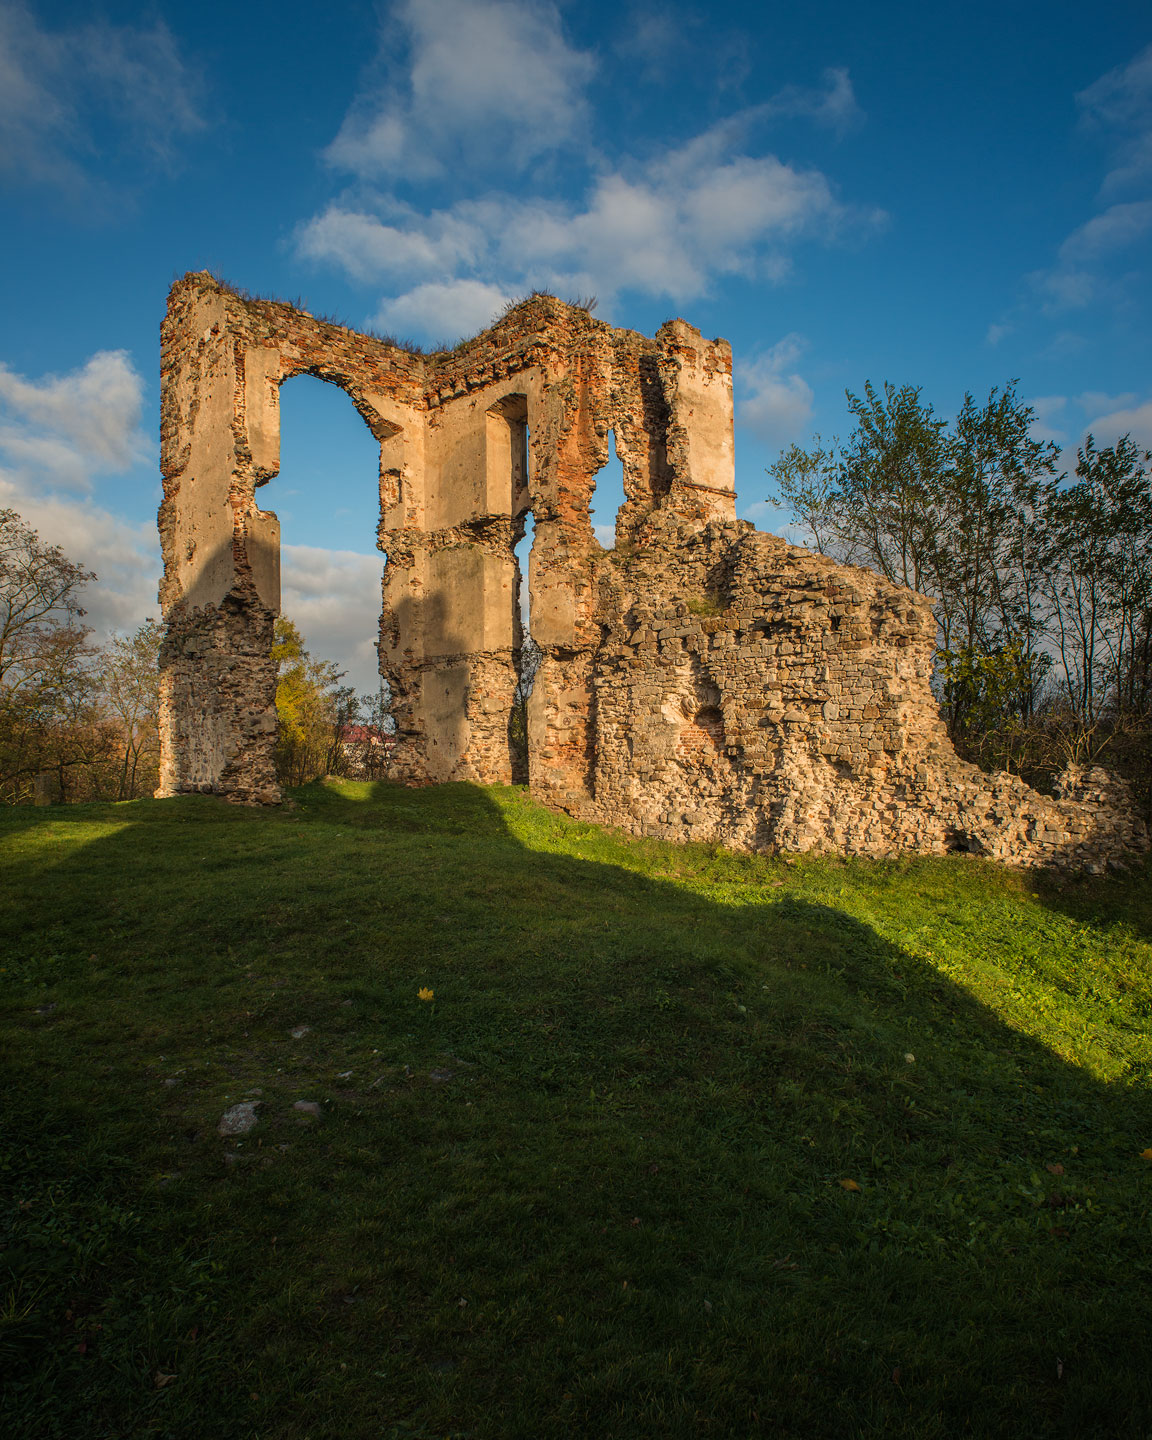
[769,382,1152,815]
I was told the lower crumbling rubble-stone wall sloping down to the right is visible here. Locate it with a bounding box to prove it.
[583,516,1146,870]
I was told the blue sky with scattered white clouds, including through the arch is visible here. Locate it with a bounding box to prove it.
[0,0,1152,688]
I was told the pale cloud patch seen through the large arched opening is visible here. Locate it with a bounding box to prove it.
[281,544,384,694]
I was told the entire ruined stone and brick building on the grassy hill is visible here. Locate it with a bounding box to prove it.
[160,274,1148,868]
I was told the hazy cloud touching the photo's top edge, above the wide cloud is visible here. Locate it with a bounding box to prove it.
[327,0,593,179]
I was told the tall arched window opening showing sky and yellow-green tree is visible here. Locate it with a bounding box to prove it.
[275,376,399,783]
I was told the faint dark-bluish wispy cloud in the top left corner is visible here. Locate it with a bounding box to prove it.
[0,0,203,193]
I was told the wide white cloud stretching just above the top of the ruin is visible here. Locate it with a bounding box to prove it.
[297,117,886,337]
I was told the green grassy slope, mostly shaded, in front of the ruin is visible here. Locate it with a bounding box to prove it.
[0,785,1152,1440]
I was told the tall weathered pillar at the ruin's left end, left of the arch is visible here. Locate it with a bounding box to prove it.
[160,276,279,804]
